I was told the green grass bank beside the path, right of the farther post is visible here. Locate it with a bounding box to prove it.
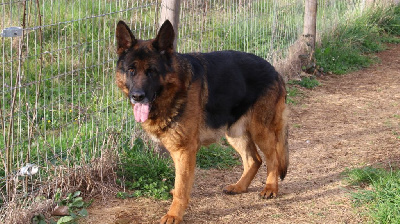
[315,6,400,74]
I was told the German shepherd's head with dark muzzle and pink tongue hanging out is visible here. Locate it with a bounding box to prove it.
[116,20,175,122]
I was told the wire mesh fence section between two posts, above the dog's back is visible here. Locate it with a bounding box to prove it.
[178,0,304,61]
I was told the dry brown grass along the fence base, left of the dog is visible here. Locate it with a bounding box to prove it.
[0,135,118,224]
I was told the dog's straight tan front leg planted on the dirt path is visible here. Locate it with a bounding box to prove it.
[160,148,197,224]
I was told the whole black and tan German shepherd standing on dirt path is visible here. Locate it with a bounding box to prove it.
[116,20,289,223]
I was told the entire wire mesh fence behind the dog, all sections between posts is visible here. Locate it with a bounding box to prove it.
[0,0,396,220]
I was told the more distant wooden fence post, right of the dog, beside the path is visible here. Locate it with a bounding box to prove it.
[303,0,317,54]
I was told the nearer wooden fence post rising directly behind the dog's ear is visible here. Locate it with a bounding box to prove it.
[159,0,181,50]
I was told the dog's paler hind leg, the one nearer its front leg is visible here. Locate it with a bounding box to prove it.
[224,132,262,194]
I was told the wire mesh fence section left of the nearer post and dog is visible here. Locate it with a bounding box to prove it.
[0,0,159,214]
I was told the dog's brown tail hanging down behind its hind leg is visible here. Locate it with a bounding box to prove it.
[276,97,289,180]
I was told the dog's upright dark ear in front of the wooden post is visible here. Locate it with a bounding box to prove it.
[153,20,175,54]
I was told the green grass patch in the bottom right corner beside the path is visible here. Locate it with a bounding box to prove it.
[346,167,400,223]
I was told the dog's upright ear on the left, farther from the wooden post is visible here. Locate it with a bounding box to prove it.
[115,21,137,55]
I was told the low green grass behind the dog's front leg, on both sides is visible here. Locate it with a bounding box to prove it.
[117,138,240,199]
